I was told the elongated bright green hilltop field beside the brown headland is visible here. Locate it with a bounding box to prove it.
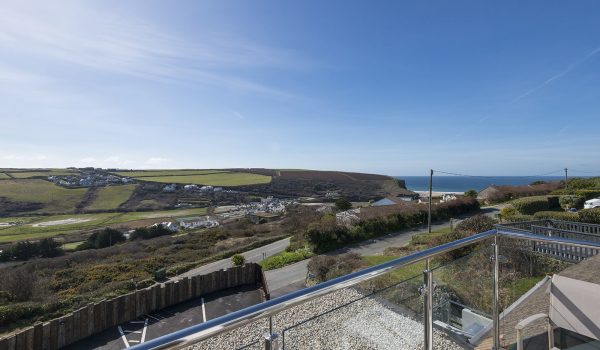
[136,173,271,186]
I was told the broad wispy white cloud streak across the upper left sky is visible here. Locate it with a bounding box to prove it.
[0,2,310,96]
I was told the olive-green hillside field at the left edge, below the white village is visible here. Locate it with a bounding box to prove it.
[0,179,87,213]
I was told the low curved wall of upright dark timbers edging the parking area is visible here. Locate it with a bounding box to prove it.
[0,263,266,350]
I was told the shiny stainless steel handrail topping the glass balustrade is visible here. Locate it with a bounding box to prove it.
[129,228,600,350]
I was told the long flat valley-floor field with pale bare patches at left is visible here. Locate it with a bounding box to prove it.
[0,208,206,243]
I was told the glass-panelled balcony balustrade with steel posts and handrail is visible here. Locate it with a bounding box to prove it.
[131,221,600,350]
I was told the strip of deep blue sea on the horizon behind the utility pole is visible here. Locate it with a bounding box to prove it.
[396,175,564,192]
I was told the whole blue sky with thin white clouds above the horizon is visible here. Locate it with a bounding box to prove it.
[0,0,600,175]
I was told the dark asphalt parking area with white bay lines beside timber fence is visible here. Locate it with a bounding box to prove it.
[64,286,263,350]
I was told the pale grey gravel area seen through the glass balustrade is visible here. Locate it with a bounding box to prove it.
[188,289,463,350]
